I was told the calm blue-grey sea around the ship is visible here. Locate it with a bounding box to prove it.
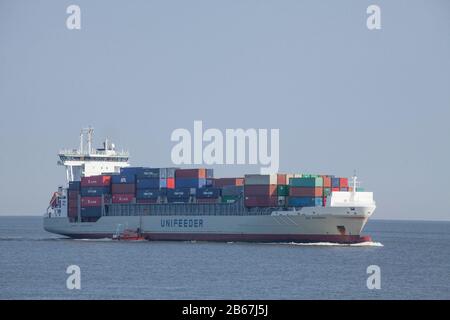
[0,216,450,300]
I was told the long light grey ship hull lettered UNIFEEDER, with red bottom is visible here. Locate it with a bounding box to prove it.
[44,207,374,243]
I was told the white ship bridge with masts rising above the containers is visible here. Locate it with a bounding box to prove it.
[58,127,129,181]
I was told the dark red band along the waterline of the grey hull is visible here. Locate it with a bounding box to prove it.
[61,233,372,243]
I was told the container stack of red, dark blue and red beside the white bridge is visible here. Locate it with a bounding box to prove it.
[80,175,111,220]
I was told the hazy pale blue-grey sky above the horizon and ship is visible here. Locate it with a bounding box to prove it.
[0,0,450,219]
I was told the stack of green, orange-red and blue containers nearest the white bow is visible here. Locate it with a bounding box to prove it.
[288,175,323,207]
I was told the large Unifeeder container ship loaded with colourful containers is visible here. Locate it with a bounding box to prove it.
[44,128,376,244]
